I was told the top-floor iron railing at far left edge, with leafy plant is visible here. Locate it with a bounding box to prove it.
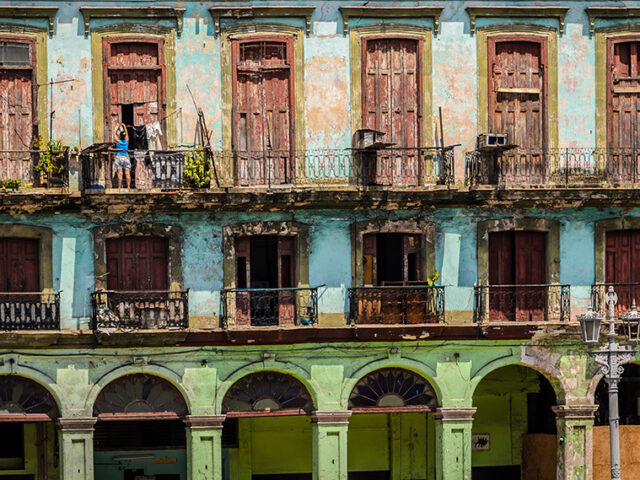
[0,148,69,189]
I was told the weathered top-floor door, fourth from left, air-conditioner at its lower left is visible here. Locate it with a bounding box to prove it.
[362,38,422,185]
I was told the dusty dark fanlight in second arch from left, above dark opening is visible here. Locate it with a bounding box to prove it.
[93,373,188,420]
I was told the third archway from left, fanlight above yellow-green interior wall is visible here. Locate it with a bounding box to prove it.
[222,371,313,480]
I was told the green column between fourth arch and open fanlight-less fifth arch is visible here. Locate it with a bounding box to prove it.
[434,407,476,480]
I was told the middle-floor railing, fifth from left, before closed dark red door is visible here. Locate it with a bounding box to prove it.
[473,284,571,323]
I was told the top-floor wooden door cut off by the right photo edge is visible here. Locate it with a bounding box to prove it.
[607,36,640,182]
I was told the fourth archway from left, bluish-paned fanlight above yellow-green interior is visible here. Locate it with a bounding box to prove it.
[348,368,438,480]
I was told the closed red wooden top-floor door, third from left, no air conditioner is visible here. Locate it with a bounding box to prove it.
[232,37,294,185]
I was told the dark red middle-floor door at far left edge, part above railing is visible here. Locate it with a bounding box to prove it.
[0,238,40,292]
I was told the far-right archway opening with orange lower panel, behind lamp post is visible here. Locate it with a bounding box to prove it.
[593,363,640,480]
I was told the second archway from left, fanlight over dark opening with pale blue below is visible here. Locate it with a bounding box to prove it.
[93,374,188,480]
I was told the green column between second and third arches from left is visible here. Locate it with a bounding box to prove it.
[184,415,226,480]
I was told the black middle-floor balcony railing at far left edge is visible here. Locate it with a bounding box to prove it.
[0,292,60,330]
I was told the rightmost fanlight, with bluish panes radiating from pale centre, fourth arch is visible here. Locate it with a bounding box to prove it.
[349,368,438,412]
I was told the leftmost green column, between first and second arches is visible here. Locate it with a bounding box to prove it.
[57,417,97,480]
